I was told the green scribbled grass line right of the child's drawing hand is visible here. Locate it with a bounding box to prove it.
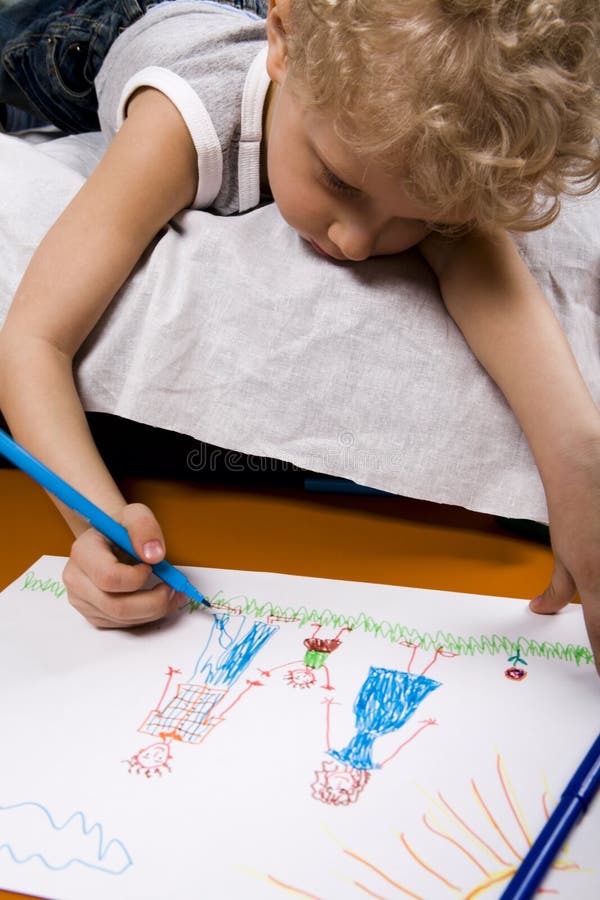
[186,590,593,666]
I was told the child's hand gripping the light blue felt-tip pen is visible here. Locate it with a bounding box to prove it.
[63,503,178,628]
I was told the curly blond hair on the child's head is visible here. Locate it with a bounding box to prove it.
[288,0,600,231]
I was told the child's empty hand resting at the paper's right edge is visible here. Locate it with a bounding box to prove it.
[531,440,600,674]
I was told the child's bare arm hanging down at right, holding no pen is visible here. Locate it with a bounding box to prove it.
[421,232,600,672]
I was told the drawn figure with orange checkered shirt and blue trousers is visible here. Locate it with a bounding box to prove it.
[126,613,279,778]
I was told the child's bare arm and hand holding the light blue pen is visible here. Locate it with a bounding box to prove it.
[0,89,197,625]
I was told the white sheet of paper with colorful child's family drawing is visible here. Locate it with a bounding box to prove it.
[0,557,600,900]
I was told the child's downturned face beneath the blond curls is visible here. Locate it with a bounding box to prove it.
[266,80,432,260]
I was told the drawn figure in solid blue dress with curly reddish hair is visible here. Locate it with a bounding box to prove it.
[311,647,455,806]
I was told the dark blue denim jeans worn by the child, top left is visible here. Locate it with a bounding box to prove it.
[0,0,268,134]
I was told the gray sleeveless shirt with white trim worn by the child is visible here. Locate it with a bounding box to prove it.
[95,0,269,215]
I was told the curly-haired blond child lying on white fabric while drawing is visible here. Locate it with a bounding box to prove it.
[0,0,600,666]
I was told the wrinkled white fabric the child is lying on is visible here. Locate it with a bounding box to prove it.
[0,128,600,521]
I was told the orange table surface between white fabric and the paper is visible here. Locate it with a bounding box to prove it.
[0,469,552,898]
